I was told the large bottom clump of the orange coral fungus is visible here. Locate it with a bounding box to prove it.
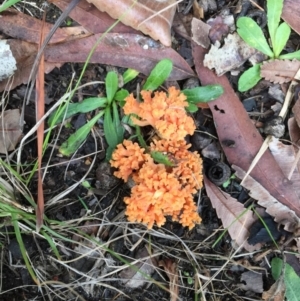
[124,160,201,229]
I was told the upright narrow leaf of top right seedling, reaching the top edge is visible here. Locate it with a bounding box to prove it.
[267,0,283,49]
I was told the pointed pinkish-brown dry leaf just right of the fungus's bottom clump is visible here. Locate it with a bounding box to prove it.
[204,177,261,252]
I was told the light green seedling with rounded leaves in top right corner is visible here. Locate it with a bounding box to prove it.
[237,0,300,92]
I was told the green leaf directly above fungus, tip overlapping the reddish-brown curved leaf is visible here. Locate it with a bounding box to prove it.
[142,59,173,91]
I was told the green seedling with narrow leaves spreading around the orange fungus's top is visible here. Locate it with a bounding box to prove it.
[48,59,224,160]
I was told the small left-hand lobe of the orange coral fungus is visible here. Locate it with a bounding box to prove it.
[110,140,150,182]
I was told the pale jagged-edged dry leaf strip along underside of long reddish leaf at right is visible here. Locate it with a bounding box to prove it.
[232,165,300,232]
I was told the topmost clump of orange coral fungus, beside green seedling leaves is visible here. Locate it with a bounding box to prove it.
[124,87,195,141]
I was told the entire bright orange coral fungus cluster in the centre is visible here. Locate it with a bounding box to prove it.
[111,87,202,229]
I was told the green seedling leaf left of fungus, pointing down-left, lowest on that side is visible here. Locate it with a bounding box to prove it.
[59,111,104,156]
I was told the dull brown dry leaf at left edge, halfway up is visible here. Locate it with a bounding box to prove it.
[0,109,22,154]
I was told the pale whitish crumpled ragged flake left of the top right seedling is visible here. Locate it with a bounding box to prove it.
[204,33,258,76]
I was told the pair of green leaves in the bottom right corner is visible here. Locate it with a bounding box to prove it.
[271,258,300,301]
